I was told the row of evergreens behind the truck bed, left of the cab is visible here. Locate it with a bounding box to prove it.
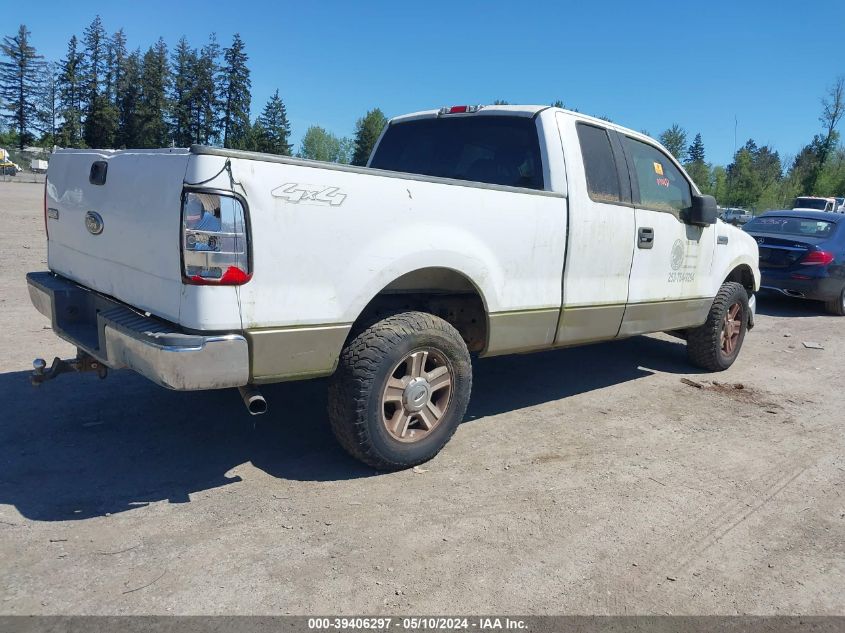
[0,16,387,165]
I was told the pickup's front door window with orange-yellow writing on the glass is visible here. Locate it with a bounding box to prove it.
[624,136,692,219]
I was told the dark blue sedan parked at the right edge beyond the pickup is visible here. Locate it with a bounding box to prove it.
[742,211,845,316]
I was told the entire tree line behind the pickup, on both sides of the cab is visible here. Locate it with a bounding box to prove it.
[0,16,845,210]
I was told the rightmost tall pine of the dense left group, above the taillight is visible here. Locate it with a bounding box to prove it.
[220,33,252,147]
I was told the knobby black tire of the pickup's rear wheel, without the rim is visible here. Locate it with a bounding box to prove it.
[328,312,472,470]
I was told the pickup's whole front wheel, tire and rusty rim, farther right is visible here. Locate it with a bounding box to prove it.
[687,281,750,371]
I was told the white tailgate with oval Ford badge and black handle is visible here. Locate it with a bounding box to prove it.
[46,149,189,322]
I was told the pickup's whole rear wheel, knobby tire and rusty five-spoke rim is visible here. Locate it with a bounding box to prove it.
[329,312,472,470]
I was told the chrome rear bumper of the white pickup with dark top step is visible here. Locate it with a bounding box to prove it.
[26,272,249,391]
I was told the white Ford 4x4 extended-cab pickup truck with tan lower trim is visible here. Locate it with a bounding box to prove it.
[28,106,760,469]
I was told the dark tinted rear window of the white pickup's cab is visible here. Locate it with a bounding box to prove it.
[370,115,545,189]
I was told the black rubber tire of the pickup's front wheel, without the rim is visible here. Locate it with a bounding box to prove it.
[687,281,749,371]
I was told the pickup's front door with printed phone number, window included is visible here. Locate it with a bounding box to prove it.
[619,134,716,336]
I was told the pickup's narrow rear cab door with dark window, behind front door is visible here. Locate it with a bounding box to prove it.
[555,118,635,345]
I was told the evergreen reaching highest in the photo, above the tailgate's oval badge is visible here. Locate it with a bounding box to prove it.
[83,15,117,148]
